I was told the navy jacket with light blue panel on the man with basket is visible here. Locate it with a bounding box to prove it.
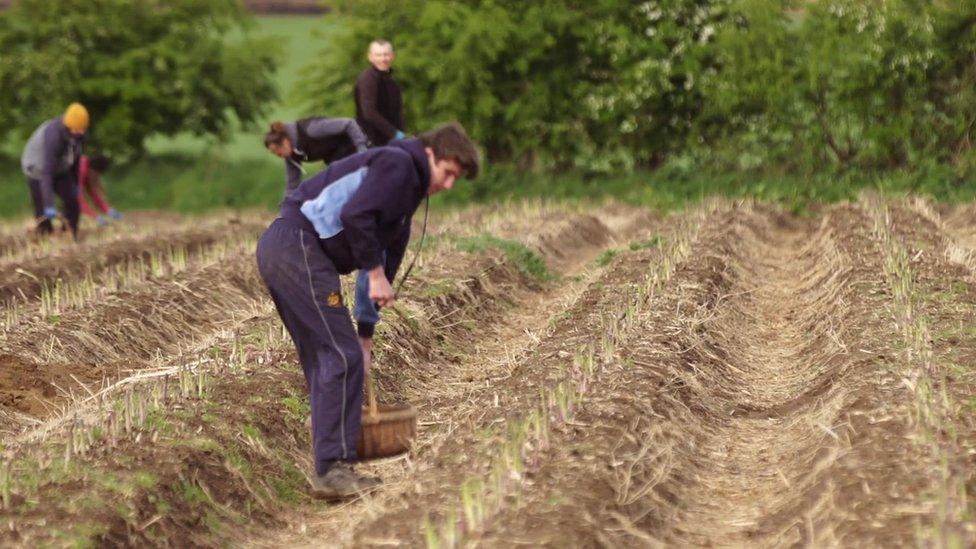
[279,139,430,281]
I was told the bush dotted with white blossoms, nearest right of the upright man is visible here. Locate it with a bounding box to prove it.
[581,0,729,169]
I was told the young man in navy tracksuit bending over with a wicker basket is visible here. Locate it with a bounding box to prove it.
[257,124,478,498]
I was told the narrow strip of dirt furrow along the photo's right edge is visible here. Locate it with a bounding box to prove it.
[868,199,976,546]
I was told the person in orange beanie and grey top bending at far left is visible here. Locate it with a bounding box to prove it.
[20,103,89,239]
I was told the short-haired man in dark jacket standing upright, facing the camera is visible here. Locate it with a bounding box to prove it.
[354,39,405,147]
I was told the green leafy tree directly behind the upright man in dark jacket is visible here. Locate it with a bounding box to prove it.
[302,0,578,167]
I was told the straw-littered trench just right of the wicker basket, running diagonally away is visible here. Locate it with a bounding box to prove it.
[249,209,659,547]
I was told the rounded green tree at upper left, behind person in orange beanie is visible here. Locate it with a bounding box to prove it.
[0,0,276,156]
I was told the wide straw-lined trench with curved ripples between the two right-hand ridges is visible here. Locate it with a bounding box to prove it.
[664,212,848,545]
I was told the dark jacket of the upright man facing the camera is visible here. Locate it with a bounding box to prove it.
[355,66,403,147]
